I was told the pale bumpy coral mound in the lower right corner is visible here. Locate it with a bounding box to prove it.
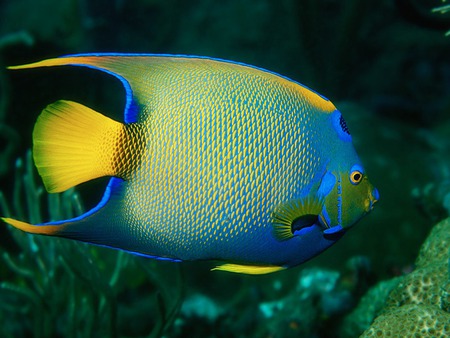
[361,218,450,337]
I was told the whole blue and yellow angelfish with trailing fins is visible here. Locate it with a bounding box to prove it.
[2,53,379,274]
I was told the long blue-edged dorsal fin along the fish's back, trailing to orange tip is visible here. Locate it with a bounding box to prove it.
[8,54,336,123]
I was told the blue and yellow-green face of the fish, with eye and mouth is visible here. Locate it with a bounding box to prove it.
[319,163,380,231]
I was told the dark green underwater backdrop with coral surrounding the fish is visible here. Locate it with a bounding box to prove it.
[0,0,450,337]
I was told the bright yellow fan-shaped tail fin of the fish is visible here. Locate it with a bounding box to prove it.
[33,100,126,192]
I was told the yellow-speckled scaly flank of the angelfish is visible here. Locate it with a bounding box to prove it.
[121,63,336,258]
